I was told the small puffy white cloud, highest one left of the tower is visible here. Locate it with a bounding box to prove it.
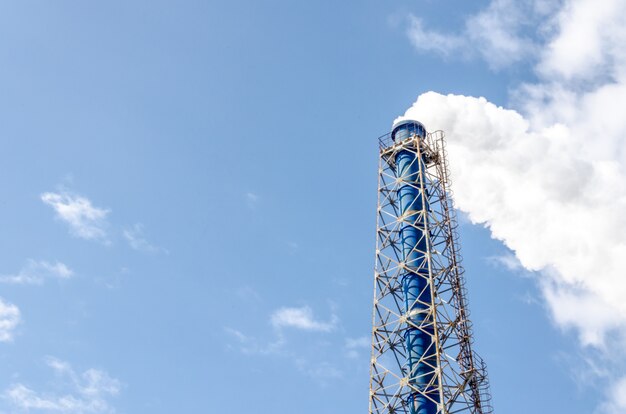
[41,192,110,242]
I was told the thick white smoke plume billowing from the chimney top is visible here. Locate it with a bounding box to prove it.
[398,93,626,345]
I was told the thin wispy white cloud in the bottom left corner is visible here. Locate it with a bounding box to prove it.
[2,358,121,414]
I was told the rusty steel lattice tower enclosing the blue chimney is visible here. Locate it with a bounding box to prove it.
[369,121,493,414]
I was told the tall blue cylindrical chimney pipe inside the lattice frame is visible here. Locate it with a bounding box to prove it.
[391,121,439,414]
